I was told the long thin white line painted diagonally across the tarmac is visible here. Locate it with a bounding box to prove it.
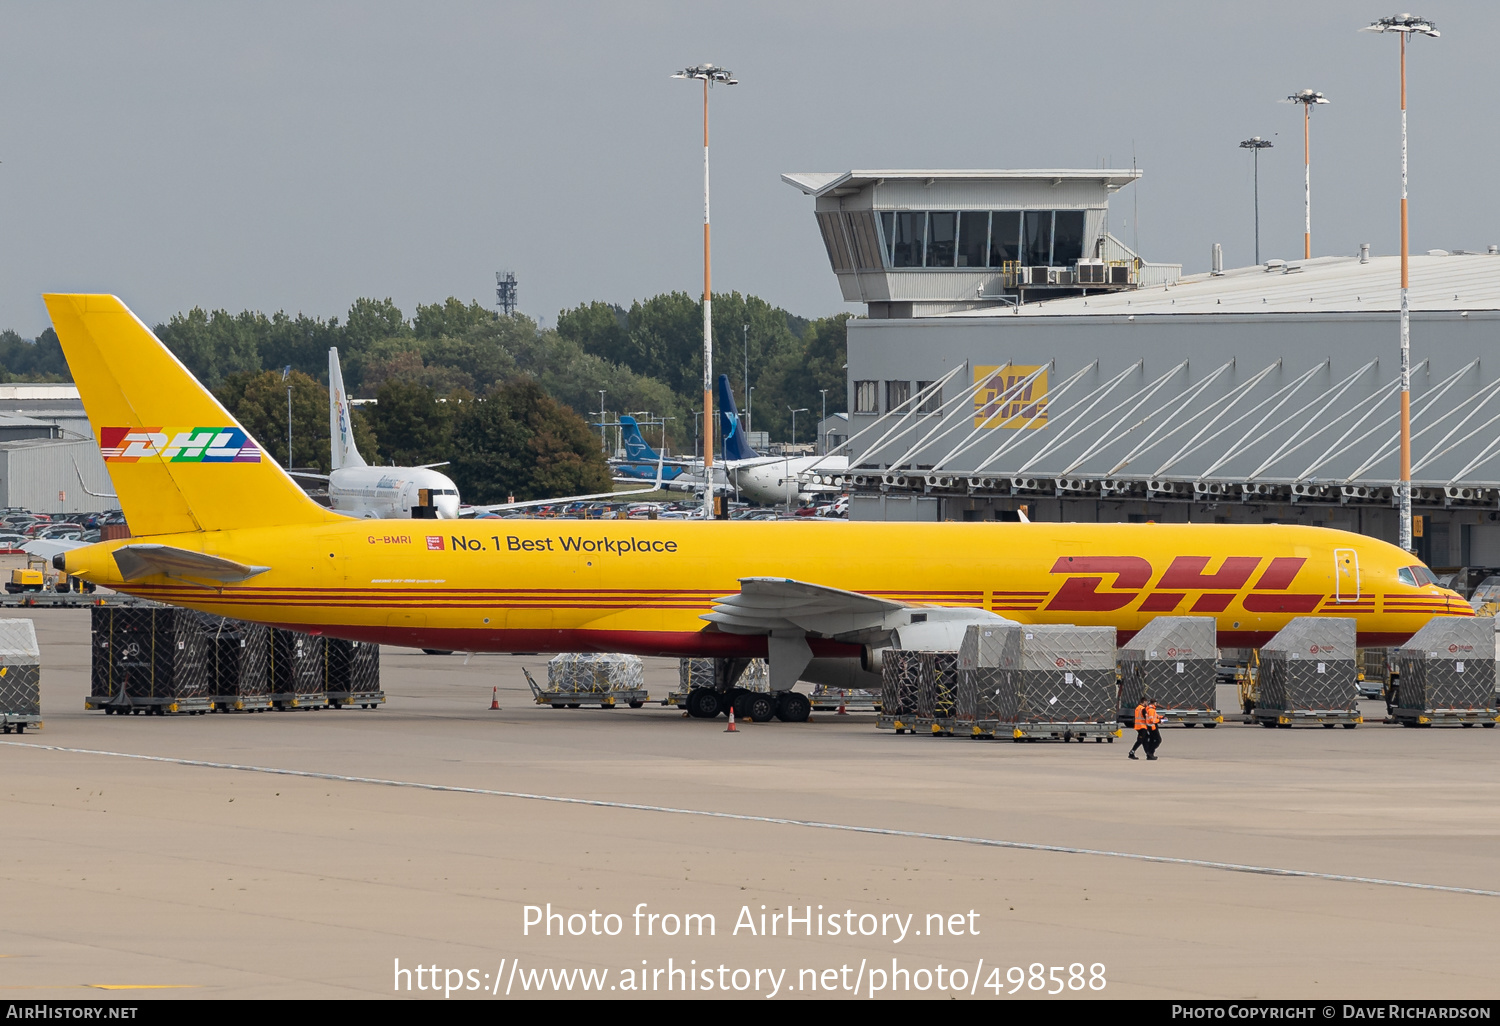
[0,741,1500,897]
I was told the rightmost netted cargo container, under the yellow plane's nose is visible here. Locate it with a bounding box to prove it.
[1391,617,1500,728]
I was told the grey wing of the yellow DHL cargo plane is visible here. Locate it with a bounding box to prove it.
[702,578,905,636]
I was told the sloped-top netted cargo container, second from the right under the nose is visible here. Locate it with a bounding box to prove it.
[1251,617,1364,728]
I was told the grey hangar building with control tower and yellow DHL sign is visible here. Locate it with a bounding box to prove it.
[783,171,1500,567]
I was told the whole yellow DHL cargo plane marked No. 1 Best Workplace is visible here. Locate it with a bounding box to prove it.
[47,296,1472,720]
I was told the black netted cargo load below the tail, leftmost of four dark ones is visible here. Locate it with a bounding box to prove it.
[84,606,215,716]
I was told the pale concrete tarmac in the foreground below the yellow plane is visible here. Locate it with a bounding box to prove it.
[0,611,1500,1001]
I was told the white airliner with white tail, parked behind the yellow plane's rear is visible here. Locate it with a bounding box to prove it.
[297,350,459,521]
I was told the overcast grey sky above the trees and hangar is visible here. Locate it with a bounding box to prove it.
[0,0,1500,336]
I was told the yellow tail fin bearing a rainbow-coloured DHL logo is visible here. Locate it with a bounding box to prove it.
[44,294,338,536]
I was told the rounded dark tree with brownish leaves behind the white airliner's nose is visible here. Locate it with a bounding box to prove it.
[450,378,611,503]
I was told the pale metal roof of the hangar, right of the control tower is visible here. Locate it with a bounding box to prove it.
[948,254,1500,317]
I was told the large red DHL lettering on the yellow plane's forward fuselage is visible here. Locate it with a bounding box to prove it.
[1046,557,1325,614]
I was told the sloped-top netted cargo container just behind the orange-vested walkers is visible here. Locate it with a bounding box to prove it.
[1119,617,1224,726]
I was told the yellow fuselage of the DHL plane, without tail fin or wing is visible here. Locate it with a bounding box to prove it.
[66,521,1472,657]
